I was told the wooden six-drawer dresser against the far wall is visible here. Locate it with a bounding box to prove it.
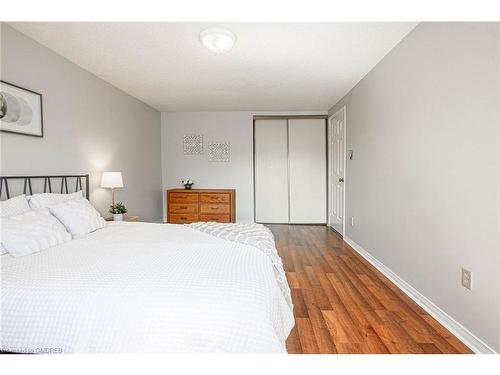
[166,189,236,224]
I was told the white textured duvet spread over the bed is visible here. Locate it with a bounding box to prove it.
[0,223,294,353]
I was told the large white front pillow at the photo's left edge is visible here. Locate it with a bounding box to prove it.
[0,209,71,257]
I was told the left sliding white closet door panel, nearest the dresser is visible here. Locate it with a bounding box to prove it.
[254,120,288,223]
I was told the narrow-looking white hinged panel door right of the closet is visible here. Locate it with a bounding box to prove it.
[328,109,345,235]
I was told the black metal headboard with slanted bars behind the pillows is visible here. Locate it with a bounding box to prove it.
[0,174,89,200]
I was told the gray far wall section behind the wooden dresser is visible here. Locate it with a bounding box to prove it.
[162,112,253,221]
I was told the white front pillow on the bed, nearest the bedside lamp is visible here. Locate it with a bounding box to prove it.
[49,198,106,238]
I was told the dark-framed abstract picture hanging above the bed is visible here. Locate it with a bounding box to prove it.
[0,81,43,137]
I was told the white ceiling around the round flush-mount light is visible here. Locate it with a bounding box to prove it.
[9,22,416,111]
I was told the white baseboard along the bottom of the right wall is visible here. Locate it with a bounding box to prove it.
[344,237,496,354]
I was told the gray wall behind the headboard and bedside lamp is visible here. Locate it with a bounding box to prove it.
[0,24,162,221]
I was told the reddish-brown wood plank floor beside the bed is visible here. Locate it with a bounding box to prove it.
[268,225,471,353]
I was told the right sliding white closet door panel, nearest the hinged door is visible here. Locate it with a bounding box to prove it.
[288,119,327,224]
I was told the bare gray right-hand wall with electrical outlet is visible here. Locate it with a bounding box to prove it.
[330,23,500,351]
